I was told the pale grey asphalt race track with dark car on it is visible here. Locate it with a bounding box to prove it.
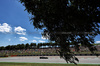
[0,56,100,64]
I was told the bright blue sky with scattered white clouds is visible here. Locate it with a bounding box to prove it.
[0,0,100,46]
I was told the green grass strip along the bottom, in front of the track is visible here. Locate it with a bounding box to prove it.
[0,62,100,66]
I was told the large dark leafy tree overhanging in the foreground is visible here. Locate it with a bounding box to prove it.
[20,0,100,63]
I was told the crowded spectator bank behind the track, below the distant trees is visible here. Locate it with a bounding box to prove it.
[0,44,100,56]
